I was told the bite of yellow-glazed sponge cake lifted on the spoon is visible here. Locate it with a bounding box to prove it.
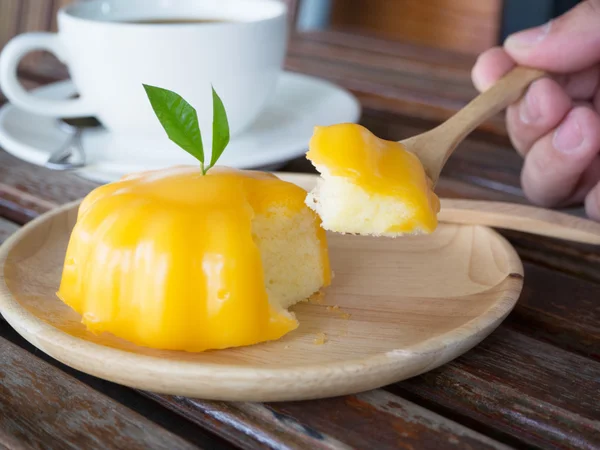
[306,124,440,237]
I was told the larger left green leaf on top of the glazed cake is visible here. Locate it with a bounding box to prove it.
[144,84,205,165]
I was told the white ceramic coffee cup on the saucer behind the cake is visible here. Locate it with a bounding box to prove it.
[0,0,287,136]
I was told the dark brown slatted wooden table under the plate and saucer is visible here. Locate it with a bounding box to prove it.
[0,32,600,449]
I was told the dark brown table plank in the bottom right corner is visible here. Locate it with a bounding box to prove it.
[389,326,600,449]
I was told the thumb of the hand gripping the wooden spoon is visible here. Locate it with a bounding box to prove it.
[504,0,600,73]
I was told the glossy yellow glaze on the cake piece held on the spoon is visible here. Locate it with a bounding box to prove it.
[307,123,440,233]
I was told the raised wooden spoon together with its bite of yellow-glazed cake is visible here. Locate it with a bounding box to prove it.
[306,67,544,237]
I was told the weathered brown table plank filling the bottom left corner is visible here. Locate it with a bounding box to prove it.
[0,338,198,450]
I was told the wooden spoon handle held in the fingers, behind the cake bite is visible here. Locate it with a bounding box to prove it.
[400,67,545,185]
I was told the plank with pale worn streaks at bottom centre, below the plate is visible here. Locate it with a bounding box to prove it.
[148,390,507,450]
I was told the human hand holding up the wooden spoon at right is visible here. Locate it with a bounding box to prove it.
[472,0,600,221]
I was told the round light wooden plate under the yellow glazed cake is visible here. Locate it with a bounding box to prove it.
[0,176,523,401]
